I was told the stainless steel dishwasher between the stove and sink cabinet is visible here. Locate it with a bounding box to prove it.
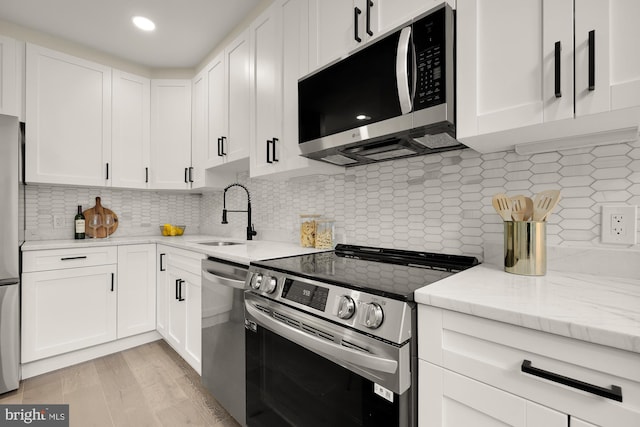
[202,257,248,426]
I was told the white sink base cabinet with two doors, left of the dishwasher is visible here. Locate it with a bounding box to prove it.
[157,245,204,373]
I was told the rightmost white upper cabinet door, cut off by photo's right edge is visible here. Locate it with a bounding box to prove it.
[575,0,640,116]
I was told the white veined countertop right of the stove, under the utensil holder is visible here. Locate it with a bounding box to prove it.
[415,264,640,353]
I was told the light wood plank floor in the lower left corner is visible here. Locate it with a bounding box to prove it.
[0,340,239,427]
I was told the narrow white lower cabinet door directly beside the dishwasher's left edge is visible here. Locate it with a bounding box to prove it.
[183,275,202,374]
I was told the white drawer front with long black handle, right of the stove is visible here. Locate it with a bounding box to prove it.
[418,306,640,427]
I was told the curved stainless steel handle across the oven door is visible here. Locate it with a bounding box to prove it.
[245,302,398,374]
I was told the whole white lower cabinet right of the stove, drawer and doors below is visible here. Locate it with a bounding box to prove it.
[418,305,640,427]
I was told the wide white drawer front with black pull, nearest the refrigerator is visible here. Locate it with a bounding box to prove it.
[22,246,118,273]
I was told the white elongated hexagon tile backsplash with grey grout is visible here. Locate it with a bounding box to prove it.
[27,142,640,257]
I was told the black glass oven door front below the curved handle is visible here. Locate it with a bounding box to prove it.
[245,325,408,427]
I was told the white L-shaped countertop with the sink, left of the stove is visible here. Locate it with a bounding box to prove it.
[22,235,326,265]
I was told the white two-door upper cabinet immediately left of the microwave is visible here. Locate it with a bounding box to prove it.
[250,0,344,178]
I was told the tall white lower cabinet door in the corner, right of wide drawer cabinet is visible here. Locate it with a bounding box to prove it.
[118,244,156,338]
